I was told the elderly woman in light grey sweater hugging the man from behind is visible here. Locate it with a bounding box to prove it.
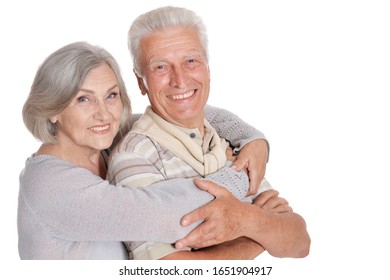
[18,42,270,259]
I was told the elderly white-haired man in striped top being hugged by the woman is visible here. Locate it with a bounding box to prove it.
[108,7,310,259]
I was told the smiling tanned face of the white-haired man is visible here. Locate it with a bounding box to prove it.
[139,28,210,128]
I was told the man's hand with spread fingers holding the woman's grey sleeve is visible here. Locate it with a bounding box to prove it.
[176,180,250,249]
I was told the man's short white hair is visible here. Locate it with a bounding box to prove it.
[128,6,209,77]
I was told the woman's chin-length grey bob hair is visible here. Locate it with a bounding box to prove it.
[23,42,131,143]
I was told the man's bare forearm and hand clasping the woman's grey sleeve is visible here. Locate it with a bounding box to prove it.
[176,181,310,258]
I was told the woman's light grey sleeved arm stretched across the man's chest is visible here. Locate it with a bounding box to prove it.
[20,157,247,243]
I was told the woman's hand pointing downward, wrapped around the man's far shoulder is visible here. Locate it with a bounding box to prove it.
[232,139,268,195]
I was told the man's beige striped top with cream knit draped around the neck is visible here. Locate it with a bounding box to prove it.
[108,107,272,259]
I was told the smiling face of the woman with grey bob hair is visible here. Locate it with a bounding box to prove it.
[51,63,123,151]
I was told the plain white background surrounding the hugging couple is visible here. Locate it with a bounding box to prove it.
[0,0,390,279]
